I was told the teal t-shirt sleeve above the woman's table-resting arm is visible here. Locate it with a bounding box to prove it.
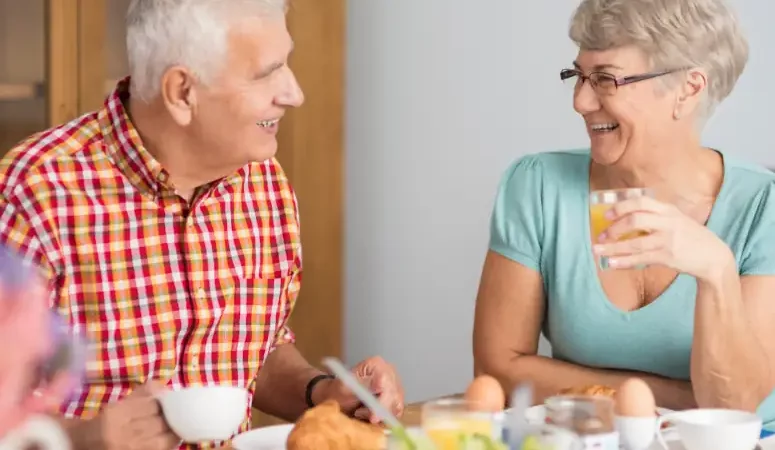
[490,155,544,271]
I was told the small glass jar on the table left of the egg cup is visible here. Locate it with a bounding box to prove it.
[545,395,619,450]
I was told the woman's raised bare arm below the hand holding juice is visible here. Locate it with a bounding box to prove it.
[691,254,775,411]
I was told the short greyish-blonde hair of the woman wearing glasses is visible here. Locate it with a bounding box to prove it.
[569,0,748,119]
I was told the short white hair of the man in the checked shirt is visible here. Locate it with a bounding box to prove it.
[126,0,287,101]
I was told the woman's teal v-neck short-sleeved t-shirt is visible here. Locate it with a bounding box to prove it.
[490,150,775,429]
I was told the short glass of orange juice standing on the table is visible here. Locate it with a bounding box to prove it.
[421,398,502,450]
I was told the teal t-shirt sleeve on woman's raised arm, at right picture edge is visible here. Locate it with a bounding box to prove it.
[740,182,775,275]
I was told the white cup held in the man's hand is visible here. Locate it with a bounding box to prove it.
[158,386,248,443]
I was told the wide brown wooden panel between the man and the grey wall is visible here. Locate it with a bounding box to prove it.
[253,0,346,426]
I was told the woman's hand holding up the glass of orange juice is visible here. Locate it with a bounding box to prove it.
[594,197,734,280]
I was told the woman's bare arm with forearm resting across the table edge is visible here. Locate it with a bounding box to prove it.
[474,251,696,409]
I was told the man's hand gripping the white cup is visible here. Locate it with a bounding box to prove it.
[67,382,181,450]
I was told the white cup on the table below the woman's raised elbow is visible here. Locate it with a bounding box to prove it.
[657,409,762,450]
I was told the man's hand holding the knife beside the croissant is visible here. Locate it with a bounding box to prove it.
[313,357,404,423]
